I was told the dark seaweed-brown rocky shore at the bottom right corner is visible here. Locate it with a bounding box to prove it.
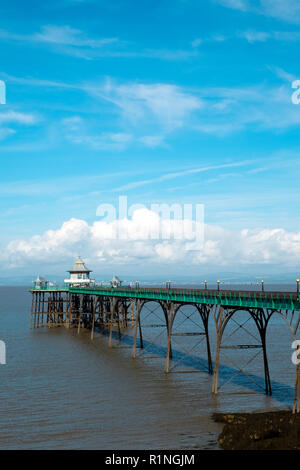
[213,410,300,450]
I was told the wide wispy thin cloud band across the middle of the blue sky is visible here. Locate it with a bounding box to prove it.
[4,74,300,143]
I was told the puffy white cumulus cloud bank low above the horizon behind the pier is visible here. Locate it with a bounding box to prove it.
[0,209,300,270]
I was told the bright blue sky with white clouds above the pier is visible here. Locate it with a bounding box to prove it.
[0,0,300,282]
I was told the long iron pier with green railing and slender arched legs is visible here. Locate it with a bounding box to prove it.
[30,285,300,413]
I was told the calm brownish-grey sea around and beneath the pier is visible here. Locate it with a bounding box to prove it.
[0,286,295,450]
